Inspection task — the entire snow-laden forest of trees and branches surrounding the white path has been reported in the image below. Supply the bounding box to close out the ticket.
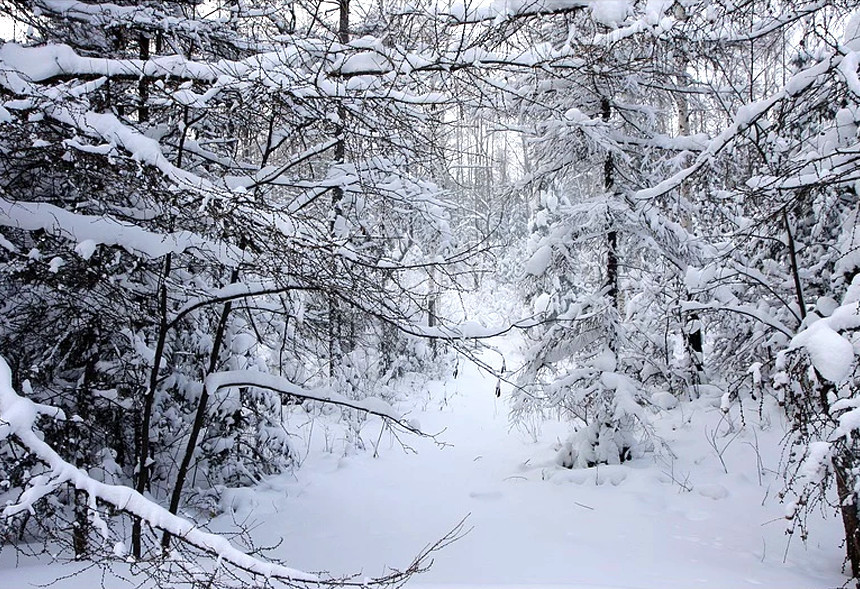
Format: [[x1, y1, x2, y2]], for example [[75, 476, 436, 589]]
[[0, 0, 860, 586]]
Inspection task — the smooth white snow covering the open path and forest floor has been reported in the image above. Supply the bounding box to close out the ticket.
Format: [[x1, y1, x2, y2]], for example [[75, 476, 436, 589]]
[[0, 338, 845, 589]]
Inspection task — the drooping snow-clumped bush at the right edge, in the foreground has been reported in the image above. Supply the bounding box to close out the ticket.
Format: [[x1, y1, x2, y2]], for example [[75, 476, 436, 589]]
[[775, 275, 860, 578]]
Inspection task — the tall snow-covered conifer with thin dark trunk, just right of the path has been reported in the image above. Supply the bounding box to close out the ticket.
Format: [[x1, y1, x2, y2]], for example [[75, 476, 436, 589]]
[[426, 2, 716, 466]]
